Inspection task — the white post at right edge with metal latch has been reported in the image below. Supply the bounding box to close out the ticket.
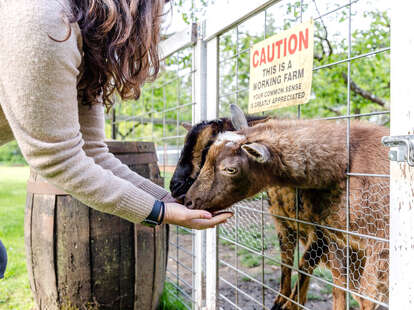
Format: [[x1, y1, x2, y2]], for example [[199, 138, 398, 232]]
[[390, 1, 414, 310]]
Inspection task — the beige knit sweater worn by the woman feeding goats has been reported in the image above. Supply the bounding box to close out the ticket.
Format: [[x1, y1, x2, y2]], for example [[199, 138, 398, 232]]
[[0, 0, 168, 223]]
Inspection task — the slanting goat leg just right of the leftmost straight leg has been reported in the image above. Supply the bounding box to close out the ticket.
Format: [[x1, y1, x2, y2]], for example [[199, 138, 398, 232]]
[[281, 228, 328, 310]]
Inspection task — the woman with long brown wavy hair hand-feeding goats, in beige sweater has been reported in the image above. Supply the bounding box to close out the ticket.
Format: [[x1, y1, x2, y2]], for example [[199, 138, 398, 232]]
[[0, 0, 233, 276]]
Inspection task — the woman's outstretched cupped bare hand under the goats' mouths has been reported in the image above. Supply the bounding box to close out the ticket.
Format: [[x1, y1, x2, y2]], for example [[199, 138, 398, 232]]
[[164, 202, 232, 229]]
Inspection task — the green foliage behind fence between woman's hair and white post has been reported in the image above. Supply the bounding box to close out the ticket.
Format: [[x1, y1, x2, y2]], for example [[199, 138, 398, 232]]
[[115, 48, 193, 146]]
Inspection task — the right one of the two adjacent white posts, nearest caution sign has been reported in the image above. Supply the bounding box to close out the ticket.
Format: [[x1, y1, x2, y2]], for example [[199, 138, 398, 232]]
[[205, 37, 219, 310]]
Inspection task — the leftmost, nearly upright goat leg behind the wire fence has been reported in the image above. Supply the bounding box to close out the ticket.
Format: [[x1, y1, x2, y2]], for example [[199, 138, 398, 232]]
[[272, 225, 297, 310]]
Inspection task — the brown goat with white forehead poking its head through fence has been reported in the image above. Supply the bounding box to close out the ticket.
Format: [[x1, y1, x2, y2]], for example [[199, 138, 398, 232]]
[[181, 105, 389, 310]]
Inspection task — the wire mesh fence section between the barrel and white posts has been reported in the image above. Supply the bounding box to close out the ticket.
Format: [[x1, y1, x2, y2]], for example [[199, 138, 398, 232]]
[[107, 46, 195, 309]]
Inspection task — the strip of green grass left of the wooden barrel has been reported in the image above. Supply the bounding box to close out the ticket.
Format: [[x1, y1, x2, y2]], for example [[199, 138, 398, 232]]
[[0, 166, 34, 310]]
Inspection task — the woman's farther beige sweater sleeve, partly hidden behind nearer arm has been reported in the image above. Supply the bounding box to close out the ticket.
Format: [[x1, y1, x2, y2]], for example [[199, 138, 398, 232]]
[[79, 104, 169, 200]]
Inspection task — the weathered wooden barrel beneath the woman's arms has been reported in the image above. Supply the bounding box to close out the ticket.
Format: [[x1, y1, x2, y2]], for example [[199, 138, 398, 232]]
[[25, 142, 168, 310]]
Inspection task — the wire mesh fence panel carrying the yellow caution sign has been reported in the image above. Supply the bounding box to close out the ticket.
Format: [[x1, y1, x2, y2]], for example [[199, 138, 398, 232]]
[[218, 0, 390, 309]]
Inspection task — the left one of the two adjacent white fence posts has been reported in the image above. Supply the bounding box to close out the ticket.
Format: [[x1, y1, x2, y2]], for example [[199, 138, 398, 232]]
[[193, 21, 207, 310]]
